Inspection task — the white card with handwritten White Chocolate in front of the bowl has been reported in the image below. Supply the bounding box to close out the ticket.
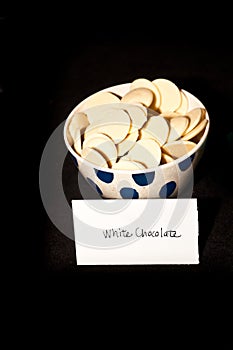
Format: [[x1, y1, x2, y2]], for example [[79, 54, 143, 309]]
[[72, 198, 199, 265]]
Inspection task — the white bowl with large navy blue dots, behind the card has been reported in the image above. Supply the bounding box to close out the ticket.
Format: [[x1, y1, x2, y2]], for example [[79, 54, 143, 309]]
[[64, 83, 209, 199]]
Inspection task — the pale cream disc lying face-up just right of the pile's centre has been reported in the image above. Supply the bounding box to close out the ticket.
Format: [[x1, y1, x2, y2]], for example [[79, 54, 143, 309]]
[[140, 116, 169, 146]]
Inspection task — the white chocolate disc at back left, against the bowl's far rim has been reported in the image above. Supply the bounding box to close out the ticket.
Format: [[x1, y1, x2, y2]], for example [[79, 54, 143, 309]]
[[78, 91, 120, 111]]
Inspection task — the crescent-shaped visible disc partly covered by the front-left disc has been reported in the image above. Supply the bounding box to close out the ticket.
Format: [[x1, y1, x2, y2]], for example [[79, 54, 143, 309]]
[[83, 134, 117, 166]]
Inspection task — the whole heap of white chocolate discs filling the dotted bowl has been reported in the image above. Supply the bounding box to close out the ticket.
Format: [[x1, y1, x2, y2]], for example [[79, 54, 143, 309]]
[[67, 78, 208, 170]]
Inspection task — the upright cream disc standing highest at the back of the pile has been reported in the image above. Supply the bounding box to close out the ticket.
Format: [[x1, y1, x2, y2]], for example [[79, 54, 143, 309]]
[[152, 79, 181, 113]]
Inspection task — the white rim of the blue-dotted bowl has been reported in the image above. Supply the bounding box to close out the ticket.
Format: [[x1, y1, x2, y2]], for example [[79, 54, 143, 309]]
[[63, 83, 210, 174]]
